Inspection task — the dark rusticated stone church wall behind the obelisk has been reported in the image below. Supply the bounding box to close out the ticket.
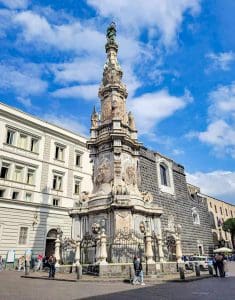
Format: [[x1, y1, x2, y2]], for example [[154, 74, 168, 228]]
[[139, 147, 213, 255]]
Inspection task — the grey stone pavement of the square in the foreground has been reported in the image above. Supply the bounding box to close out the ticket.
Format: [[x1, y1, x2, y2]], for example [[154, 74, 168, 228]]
[[0, 262, 235, 300]]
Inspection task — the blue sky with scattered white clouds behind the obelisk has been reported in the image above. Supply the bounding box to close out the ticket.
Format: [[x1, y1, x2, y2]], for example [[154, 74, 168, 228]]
[[0, 0, 235, 203]]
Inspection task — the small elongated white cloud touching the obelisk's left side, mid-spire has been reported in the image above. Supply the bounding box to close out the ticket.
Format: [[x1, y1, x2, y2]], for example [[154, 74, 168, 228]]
[[52, 84, 99, 100]]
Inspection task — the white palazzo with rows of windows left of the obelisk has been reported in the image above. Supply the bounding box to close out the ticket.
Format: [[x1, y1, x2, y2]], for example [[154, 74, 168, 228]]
[[0, 103, 92, 258]]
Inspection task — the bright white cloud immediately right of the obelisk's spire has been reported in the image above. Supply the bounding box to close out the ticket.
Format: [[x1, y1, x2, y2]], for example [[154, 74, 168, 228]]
[[129, 90, 192, 134]]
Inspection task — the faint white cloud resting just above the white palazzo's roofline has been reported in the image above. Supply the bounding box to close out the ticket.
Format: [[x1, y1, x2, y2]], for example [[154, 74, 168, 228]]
[[42, 113, 89, 136]]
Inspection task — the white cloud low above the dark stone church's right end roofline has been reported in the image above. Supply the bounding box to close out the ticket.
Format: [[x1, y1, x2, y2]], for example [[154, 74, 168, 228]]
[[186, 170, 235, 204]]
